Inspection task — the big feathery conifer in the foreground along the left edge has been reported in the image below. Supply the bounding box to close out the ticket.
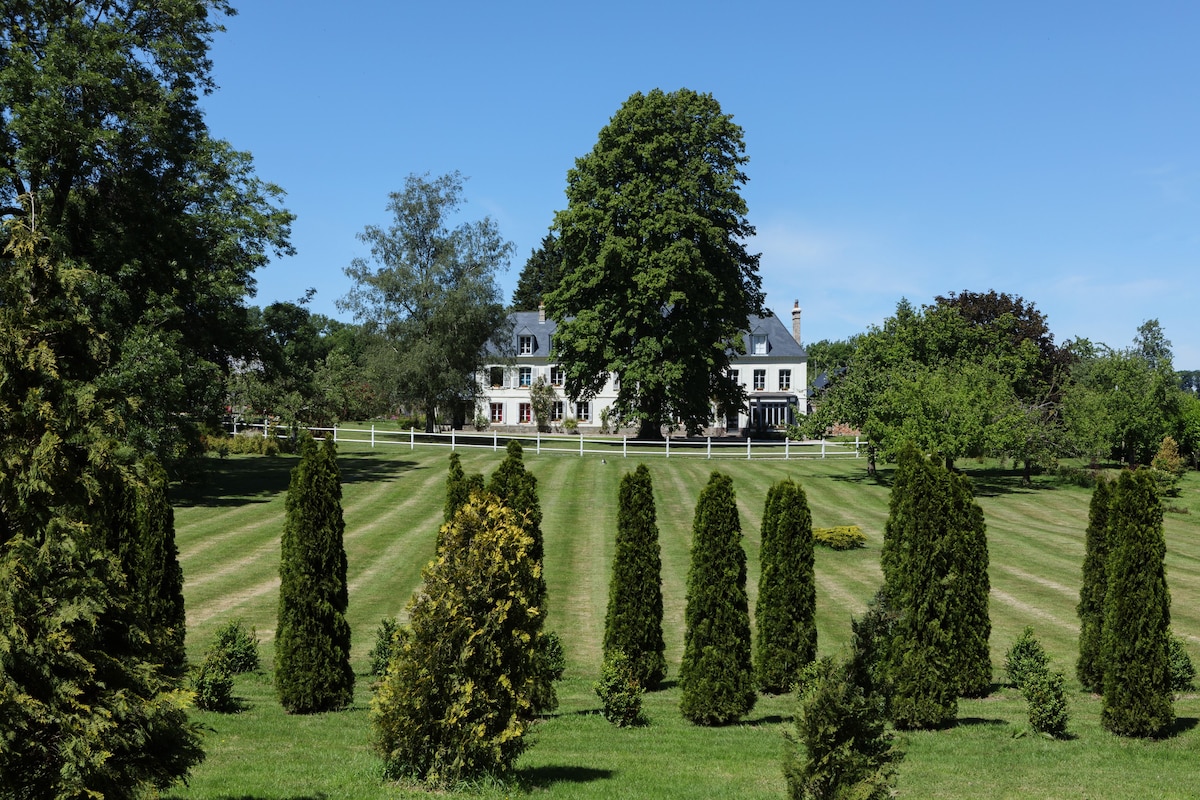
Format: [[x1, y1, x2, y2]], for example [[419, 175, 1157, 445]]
[[0, 215, 203, 798]]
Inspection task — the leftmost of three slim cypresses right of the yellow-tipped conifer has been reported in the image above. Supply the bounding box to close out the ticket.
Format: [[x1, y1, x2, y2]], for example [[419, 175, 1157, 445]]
[[604, 464, 667, 688]]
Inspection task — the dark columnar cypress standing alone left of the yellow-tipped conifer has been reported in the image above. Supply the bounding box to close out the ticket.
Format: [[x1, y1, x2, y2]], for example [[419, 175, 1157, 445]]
[[275, 433, 354, 714]]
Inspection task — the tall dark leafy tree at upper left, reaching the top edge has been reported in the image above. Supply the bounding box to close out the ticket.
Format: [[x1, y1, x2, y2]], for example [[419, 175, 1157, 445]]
[[0, 0, 292, 470]]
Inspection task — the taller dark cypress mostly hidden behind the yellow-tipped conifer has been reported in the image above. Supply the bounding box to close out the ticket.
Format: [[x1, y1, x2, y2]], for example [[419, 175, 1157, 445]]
[[487, 439, 562, 714]]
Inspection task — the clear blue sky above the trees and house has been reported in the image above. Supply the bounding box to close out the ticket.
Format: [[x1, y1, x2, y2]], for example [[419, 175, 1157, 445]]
[[204, 0, 1200, 369]]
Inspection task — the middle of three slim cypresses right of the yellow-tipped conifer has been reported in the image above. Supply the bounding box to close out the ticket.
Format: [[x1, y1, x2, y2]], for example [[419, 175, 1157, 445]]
[[679, 473, 757, 724]]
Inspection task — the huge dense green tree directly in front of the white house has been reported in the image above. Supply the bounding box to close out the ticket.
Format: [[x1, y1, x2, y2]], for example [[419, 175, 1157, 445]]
[[546, 89, 763, 438]]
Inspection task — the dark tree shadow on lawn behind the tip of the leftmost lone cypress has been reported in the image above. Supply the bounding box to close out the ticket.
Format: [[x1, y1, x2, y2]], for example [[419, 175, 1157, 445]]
[[172, 455, 415, 507]]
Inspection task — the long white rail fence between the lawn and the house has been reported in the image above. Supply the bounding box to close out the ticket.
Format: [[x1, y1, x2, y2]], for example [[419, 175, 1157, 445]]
[[229, 421, 866, 459]]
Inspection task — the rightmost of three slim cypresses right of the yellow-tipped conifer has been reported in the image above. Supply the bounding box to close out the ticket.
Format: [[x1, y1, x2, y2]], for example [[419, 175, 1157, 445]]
[[755, 480, 817, 694]]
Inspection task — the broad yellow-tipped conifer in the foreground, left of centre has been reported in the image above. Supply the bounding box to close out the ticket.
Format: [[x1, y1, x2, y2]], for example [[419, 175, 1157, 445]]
[[371, 495, 545, 786]]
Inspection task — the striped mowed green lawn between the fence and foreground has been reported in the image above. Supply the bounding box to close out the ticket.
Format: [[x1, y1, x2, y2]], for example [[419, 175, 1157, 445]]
[[168, 445, 1200, 800]]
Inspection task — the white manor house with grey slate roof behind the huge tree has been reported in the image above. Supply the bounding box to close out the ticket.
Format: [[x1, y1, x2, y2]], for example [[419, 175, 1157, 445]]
[[475, 301, 808, 435]]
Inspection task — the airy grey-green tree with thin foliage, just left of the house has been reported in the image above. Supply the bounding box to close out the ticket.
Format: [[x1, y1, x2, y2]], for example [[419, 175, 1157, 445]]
[[338, 172, 512, 432]]
